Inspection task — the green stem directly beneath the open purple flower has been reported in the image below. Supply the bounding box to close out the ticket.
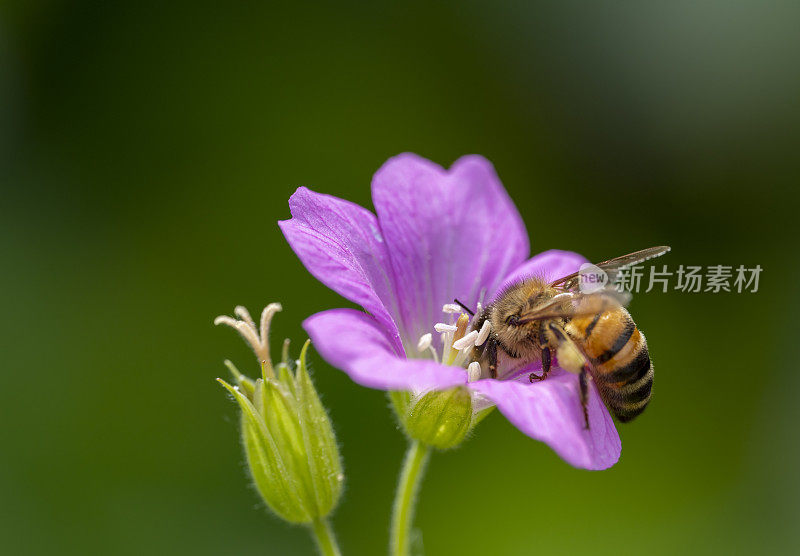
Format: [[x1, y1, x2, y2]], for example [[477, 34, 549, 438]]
[[389, 440, 431, 556]]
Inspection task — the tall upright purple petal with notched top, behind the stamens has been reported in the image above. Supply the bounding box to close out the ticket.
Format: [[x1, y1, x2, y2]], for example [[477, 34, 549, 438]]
[[372, 153, 529, 341]]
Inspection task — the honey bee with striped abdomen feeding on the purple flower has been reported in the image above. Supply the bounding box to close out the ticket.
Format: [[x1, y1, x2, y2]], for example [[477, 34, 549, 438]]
[[466, 246, 670, 428]]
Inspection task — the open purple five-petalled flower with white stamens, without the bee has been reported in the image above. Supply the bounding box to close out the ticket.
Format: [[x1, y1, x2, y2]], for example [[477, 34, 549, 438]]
[[279, 154, 621, 469]]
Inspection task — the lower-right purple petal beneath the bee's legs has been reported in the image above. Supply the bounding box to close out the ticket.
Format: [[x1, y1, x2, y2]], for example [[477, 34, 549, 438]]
[[469, 369, 622, 470]]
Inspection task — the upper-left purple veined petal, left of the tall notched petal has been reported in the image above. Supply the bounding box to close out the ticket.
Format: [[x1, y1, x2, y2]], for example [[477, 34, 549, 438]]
[[278, 187, 399, 342]]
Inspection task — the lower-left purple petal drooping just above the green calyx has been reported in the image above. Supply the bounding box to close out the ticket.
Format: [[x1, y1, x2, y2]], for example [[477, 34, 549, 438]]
[[303, 309, 467, 391]]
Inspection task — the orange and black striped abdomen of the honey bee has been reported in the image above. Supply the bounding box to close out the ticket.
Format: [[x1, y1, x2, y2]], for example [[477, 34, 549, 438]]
[[566, 307, 653, 422]]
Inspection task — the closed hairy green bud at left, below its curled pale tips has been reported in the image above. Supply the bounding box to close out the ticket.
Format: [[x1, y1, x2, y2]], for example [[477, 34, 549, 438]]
[[218, 330, 344, 523]]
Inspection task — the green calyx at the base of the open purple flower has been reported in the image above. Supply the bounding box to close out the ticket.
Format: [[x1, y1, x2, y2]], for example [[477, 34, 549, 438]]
[[390, 386, 487, 450]]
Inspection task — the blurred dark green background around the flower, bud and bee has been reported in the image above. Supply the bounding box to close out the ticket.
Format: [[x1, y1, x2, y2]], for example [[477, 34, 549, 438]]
[[0, 0, 800, 555]]
